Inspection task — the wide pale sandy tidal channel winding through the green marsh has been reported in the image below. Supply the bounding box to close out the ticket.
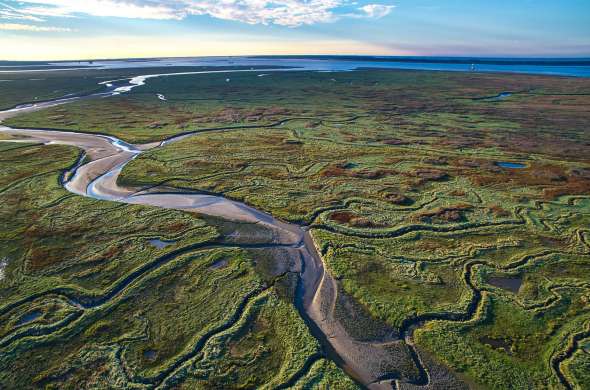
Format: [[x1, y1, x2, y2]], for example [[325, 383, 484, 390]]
[[0, 69, 415, 389]]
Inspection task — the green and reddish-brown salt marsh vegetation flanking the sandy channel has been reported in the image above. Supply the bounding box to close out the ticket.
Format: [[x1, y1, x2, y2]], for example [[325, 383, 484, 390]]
[[0, 70, 590, 388]]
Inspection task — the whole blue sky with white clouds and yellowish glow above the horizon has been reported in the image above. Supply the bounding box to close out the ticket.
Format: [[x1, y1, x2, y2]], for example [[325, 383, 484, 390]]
[[0, 0, 590, 60]]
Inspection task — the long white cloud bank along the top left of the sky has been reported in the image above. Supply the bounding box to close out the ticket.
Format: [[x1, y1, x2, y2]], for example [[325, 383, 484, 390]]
[[0, 0, 393, 27]]
